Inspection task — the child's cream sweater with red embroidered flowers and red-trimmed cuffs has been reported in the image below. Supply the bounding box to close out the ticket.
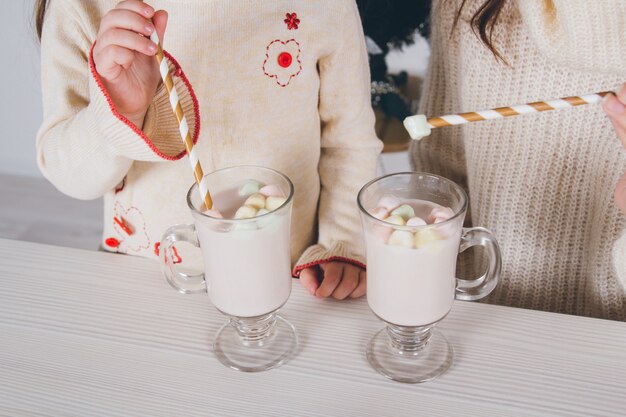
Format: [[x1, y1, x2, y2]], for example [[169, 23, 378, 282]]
[[37, 0, 381, 275]]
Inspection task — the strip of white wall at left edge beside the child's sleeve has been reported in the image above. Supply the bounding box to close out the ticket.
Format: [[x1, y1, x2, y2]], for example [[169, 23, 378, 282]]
[[0, 0, 41, 176]]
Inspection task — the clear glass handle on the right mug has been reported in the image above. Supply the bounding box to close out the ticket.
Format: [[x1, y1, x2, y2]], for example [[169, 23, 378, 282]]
[[456, 227, 502, 301]]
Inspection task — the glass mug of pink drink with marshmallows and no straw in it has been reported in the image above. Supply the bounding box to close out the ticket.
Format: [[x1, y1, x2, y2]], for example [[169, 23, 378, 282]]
[[358, 172, 502, 383]]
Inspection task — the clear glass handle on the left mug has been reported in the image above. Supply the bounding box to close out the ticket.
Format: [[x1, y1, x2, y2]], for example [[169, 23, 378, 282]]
[[159, 224, 207, 294]]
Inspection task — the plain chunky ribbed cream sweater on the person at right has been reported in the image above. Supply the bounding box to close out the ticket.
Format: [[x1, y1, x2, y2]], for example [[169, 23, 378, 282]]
[[411, 0, 626, 320]]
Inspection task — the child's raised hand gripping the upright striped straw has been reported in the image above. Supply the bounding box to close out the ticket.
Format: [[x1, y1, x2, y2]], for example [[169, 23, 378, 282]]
[[93, 0, 167, 129]]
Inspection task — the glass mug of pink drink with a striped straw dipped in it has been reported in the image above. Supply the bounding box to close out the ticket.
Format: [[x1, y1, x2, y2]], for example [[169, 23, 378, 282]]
[[160, 166, 298, 372]]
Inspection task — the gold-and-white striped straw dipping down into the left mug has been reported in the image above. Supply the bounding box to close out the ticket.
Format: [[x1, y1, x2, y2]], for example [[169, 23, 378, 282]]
[[150, 30, 213, 210]]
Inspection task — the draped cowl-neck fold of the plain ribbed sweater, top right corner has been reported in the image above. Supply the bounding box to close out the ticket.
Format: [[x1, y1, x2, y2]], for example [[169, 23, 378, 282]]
[[517, 0, 626, 76]]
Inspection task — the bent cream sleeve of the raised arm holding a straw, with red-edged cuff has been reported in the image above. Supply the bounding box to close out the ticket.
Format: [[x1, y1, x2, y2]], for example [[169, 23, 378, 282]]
[[36, 1, 200, 199]]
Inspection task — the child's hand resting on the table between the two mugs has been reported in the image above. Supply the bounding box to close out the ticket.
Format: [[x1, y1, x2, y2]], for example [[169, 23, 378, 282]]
[[300, 262, 367, 300]]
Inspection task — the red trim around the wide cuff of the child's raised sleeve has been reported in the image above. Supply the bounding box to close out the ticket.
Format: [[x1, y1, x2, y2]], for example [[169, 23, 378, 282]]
[[89, 42, 200, 161]]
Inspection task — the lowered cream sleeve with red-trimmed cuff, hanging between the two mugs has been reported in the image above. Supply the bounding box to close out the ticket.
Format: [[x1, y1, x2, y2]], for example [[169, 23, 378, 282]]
[[294, 1, 382, 276]]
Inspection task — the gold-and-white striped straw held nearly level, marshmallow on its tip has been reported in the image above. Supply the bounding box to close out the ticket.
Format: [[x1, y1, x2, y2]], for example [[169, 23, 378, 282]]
[[427, 91, 612, 129]]
